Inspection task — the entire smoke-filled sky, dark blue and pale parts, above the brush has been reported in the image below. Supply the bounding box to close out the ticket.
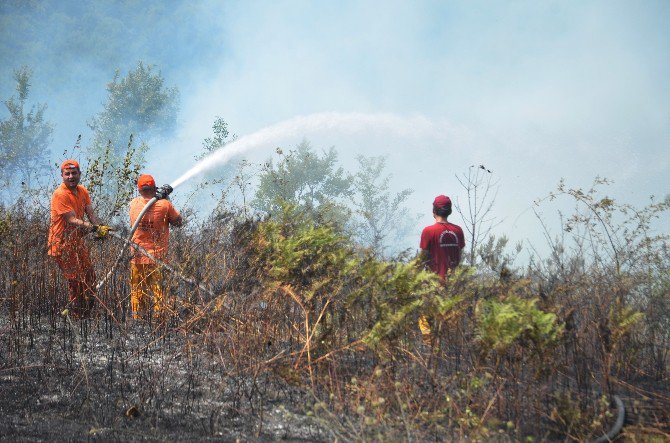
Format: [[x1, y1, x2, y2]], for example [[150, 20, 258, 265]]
[[0, 0, 670, 255]]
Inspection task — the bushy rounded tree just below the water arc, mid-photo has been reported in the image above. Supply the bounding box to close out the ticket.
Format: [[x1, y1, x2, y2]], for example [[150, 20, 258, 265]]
[[252, 141, 352, 226]]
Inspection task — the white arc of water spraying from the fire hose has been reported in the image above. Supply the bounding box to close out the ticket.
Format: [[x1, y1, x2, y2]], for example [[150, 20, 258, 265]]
[[170, 112, 437, 188]]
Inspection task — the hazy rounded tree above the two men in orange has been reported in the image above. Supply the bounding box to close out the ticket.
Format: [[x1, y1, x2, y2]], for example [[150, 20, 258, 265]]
[[89, 62, 179, 160]]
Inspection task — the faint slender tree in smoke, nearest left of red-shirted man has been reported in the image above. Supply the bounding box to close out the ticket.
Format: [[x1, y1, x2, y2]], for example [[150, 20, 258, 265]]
[[354, 155, 416, 257]]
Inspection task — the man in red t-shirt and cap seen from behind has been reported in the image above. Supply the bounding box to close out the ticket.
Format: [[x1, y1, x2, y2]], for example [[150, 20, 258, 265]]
[[419, 195, 465, 342]]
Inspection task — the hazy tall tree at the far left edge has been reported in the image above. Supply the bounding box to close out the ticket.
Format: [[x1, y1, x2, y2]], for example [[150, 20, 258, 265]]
[[0, 66, 53, 193]]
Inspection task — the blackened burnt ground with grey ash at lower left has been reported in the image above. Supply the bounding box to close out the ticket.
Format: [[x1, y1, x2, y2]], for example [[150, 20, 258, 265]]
[[0, 317, 328, 441]]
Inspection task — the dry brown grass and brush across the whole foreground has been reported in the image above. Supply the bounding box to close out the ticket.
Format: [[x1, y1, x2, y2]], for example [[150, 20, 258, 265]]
[[0, 200, 670, 441]]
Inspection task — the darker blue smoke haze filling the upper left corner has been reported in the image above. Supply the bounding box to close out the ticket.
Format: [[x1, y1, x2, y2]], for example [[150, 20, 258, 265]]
[[0, 1, 226, 158]]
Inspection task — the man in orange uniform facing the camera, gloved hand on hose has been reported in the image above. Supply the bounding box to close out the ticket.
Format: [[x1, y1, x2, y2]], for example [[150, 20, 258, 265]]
[[48, 160, 109, 318]]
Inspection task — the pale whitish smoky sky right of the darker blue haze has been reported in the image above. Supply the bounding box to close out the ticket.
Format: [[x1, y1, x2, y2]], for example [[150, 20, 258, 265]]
[[154, 1, 670, 256]]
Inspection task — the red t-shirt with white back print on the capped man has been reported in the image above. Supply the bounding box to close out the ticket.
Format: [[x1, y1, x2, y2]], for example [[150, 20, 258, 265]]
[[420, 222, 465, 279]]
